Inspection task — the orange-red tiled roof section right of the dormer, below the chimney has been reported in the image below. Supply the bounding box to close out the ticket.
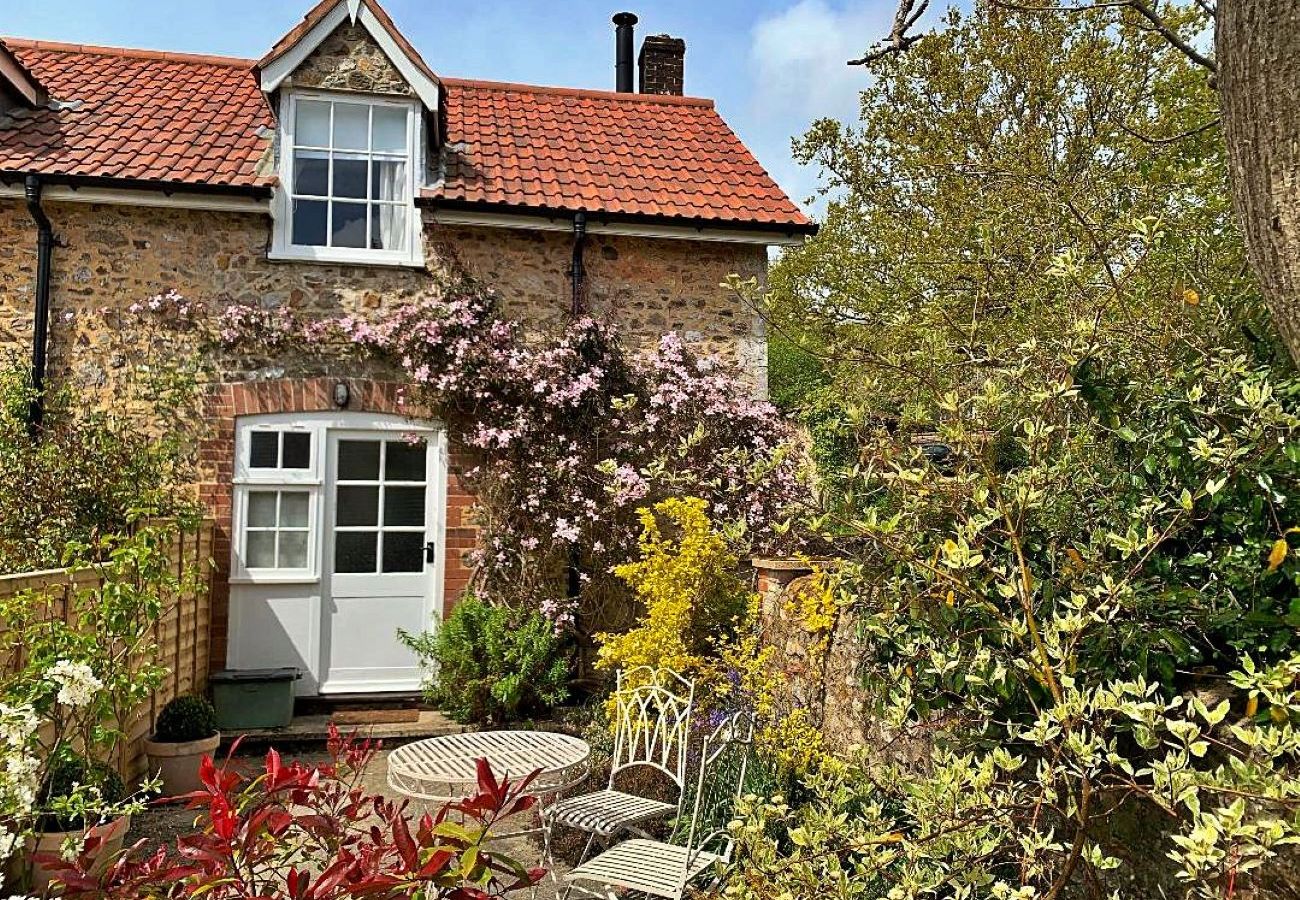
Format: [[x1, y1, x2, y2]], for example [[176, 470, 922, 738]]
[[437, 78, 809, 226]]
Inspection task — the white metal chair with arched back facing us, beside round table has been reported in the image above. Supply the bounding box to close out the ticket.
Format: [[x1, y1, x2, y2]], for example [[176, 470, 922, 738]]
[[543, 666, 696, 860]]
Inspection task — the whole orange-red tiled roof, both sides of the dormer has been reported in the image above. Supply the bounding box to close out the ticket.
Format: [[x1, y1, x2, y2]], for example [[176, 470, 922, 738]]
[[0, 38, 809, 230]]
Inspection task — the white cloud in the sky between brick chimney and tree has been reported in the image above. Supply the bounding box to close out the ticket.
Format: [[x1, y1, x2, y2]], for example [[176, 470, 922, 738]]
[[749, 0, 894, 215]]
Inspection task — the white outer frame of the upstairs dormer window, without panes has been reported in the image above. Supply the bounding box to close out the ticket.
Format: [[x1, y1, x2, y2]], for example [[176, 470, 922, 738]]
[[268, 90, 425, 267]]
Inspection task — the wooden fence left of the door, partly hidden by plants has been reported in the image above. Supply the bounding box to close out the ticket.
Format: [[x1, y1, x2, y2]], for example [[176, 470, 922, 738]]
[[0, 519, 213, 779]]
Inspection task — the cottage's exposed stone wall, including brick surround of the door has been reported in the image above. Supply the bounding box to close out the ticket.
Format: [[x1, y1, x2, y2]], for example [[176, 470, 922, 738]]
[[0, 200, 767, 663]]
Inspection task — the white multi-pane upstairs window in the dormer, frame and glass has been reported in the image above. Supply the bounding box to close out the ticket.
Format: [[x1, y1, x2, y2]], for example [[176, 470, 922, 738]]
[[272, 91, 423, 265]]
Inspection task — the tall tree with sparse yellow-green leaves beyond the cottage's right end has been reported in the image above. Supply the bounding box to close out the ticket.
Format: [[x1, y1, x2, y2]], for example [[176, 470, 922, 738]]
[[770, 4, 1271, 428]]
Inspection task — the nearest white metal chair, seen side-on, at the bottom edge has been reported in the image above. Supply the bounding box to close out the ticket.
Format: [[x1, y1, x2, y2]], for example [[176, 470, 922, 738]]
[[564, 713, 754, 900]]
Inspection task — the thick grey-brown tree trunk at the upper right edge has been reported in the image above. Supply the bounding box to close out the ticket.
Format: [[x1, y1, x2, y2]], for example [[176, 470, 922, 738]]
[[1214, 0, 1300, 362]]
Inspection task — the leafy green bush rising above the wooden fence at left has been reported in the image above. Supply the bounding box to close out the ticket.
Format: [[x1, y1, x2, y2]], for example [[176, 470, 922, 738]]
[[0, 355, 196, 572]]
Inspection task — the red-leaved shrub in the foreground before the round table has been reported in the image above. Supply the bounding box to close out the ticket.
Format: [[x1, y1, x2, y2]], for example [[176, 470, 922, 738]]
[[43, 726, 543, 900]]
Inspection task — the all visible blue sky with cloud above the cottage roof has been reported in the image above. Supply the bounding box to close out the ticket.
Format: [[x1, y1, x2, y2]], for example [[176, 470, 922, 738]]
[[0, 0, 935, 218]]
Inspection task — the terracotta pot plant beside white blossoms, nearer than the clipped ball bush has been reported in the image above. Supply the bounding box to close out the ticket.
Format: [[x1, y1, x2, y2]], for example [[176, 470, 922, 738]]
[[30, 753, 131, 895]]
